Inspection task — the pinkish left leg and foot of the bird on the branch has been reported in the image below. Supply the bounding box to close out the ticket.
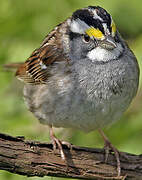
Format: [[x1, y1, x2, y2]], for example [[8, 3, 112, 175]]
[[49, 126, 72, 160]]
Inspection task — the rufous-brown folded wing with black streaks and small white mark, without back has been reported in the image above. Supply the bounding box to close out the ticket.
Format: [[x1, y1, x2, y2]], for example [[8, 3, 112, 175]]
[[16, 45, 65, 84]]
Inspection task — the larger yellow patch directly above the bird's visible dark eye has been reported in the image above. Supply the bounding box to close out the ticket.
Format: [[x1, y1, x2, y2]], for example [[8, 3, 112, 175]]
[[86, 27, 104, 39]]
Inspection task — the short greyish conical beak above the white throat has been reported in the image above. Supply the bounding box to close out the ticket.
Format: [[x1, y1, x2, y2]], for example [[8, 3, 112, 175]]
[[98, 36, 117, 50]]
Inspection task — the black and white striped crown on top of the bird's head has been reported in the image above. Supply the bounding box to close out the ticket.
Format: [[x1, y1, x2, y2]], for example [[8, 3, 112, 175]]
[[70, 6, 112, 35]]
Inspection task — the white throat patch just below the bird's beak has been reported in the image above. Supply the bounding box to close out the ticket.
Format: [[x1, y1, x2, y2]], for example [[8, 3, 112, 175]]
[[87, 43, 123, 62]]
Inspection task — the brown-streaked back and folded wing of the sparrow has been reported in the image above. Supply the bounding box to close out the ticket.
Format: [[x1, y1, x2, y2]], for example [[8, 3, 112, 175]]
[[16, 23, 67, 84]]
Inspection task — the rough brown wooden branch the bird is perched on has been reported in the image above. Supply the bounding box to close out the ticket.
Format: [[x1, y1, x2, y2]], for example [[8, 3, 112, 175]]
[[0, 134, 142, 180]]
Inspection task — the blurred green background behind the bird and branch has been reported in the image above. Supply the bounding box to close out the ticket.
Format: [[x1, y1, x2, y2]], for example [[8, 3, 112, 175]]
[[0, 0, 142, 180]]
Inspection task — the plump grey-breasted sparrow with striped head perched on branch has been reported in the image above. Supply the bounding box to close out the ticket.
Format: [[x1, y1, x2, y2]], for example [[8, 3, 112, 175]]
[[5, 6, 139, 175]]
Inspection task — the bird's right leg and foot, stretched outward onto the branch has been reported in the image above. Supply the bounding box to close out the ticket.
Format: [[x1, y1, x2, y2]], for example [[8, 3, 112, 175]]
[[98, 129, 121, 176]]
